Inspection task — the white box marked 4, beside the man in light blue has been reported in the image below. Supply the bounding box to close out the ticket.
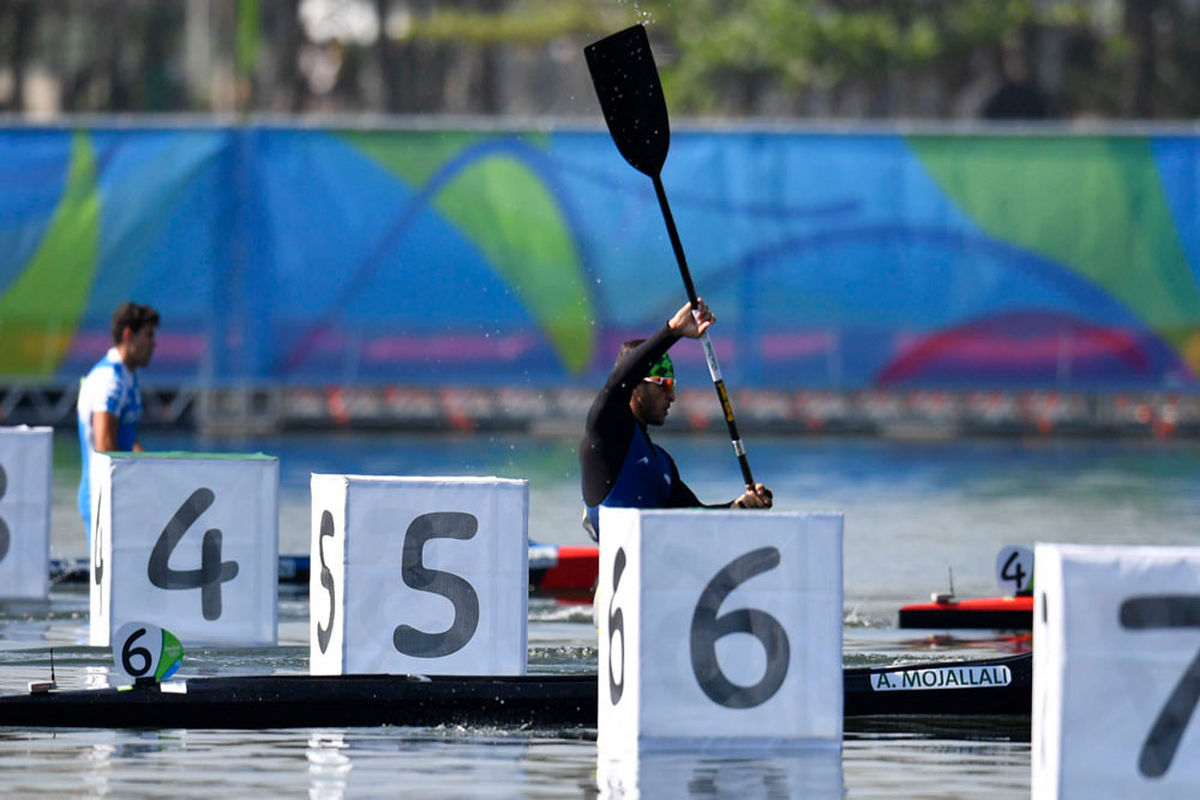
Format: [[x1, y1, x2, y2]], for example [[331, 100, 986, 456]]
[[89, 452, 280, 646]]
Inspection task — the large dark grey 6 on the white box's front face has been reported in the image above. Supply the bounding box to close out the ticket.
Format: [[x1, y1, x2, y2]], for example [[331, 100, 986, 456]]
[[691, 547, 791, 709]]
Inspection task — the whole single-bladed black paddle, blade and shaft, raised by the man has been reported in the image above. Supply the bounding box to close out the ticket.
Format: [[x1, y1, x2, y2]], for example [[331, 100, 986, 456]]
[[583, 25, 755, 496]]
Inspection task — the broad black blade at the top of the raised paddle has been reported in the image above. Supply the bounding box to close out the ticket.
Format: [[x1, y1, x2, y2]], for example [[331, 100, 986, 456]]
[[583, 25, 671, 178]]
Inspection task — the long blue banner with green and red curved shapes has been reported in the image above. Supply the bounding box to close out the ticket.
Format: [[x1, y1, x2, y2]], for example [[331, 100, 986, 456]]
[[0, 126, 1200, 391]]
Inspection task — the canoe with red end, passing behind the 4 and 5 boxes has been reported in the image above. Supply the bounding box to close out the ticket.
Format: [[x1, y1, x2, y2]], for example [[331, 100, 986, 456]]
[[50, 542, 600, 595]]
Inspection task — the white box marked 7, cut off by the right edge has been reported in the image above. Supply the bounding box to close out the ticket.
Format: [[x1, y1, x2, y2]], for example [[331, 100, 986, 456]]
[[1032, 545, 1200, 800]]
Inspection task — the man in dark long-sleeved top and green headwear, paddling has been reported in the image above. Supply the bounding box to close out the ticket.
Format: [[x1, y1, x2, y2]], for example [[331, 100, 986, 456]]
[[580, 300, 772, 541]]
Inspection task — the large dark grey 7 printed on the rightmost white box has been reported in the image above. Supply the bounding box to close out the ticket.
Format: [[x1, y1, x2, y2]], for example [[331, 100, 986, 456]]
[[1120, 595, 1200, 777]]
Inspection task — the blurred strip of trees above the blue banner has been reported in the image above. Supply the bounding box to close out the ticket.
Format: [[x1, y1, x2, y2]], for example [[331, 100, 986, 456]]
[[7, 0, 1200, 119]]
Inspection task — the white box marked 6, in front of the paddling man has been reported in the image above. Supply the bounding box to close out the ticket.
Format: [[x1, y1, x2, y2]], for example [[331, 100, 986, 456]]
[[595, 509, 842, 752]]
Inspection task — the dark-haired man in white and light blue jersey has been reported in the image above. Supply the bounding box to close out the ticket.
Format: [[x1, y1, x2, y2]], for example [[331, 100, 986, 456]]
[[76, 302, 158, 549]]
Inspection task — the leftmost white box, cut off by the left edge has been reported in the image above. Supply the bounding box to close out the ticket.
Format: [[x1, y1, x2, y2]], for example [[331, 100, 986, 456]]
[[0, 426, 53, 600]]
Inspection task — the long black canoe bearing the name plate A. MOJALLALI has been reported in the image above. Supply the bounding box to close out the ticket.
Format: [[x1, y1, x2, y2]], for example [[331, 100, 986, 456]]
[[0, 654, 1033, 730]]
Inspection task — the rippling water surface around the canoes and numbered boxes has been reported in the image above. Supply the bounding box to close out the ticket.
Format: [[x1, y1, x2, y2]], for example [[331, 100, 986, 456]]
[[9, 433, 1200, 800]]
